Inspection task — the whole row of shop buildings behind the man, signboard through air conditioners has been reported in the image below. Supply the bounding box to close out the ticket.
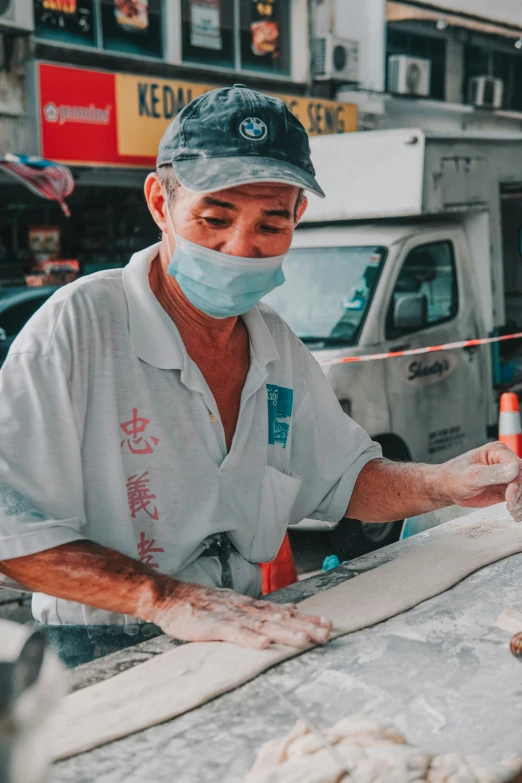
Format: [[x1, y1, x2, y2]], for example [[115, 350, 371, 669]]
[[0, 0, 522, 285]]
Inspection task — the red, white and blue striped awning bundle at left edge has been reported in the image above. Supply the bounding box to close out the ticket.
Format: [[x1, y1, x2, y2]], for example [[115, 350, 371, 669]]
[[0, 155, 74, 217]]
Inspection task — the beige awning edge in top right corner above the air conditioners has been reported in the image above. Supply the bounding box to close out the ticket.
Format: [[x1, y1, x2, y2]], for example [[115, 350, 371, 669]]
[[386, 0, 522, 40]]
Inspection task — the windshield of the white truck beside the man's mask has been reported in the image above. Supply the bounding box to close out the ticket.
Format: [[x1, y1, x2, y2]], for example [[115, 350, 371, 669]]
[[264, 247, 387, 348]]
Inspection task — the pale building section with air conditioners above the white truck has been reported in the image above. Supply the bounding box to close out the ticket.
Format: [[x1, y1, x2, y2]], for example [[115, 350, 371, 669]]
[[328, 0, 522, 133]]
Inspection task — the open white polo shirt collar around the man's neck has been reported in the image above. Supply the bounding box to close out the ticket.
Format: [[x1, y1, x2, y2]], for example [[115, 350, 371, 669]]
[[123, 242, 279, 370]]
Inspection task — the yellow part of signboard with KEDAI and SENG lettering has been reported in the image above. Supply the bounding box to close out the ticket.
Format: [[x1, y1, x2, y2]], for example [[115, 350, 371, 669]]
[[115, 73, 357, 158]]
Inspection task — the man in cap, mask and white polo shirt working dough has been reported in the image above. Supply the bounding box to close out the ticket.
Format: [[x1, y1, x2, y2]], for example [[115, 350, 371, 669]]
[[0, 85, 522, 660]]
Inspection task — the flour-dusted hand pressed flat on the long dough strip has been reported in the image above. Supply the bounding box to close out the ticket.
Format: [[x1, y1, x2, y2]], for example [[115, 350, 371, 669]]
[[144, 580, 332, 650]]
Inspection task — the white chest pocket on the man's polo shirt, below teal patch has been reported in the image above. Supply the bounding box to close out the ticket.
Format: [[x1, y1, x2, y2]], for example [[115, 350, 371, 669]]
[[248, 465, 303, 563]]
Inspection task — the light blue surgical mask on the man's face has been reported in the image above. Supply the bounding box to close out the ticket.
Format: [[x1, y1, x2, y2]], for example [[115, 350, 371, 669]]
[[167, 210, 285, 318]]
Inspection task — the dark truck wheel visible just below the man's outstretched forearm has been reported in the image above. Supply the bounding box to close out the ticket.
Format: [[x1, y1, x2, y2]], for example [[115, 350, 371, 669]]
[[328, 519, 402, 561]]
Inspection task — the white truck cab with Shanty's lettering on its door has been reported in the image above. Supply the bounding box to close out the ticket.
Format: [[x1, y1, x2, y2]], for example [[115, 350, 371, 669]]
[[266, 222, 491, 462]]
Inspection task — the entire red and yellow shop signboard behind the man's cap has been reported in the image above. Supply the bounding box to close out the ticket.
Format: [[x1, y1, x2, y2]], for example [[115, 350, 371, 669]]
[[38, 63, 357, 168]]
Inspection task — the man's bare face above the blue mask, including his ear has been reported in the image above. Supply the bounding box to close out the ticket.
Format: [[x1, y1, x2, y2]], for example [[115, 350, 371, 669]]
[[145, 174, 306, 258]]
